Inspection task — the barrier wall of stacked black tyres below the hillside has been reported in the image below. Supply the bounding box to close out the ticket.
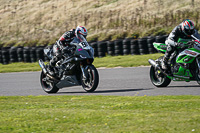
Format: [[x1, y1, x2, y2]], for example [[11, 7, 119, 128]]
[[0, 35, 168, 64]]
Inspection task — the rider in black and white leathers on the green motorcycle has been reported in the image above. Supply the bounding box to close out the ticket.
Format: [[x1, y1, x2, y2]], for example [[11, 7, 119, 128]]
[[161, 19, 195, 70]]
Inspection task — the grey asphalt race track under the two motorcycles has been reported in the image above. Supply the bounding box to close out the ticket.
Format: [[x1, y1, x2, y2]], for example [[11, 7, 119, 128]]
[[0, 67, 200, 96]]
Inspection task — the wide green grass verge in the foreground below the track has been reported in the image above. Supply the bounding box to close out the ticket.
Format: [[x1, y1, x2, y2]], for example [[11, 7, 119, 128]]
[[0, 96, 200, 133]]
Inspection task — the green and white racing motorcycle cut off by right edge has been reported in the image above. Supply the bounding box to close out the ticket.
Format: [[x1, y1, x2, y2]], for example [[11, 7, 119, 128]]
[[149, 36, 200, 87]]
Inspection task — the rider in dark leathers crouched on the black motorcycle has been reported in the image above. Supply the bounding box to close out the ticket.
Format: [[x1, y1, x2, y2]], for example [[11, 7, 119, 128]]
[[48, 26, 87, 76]]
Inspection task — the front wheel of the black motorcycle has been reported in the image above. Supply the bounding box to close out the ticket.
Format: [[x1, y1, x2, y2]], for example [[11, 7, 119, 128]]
[[81, 65, 99, 92]]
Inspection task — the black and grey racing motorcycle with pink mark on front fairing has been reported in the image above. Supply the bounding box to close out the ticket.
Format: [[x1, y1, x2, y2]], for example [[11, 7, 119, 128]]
[[39, 35, 99, 93]]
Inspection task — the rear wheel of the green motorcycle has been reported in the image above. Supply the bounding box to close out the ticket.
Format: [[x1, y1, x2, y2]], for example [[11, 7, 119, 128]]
[[150, 66, 171, 87]]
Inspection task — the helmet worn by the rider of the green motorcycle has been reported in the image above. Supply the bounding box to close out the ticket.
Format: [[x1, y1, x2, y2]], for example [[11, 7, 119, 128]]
[[181, 19, 194, 36]]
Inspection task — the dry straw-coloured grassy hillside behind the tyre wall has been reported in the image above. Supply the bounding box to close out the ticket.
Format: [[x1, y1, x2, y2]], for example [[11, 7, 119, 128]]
[[0, 0, 200, 46]]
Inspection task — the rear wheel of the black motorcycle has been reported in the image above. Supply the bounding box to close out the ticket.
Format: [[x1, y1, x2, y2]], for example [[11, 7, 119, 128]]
[[40, 71, 59, 93]]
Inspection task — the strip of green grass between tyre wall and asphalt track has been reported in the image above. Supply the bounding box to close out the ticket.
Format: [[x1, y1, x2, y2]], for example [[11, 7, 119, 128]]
[[0, 54, 162, 73]]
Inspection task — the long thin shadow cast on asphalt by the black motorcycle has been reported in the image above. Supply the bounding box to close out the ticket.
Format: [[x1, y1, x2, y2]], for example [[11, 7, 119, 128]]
[[57, 88, 154, 94]]
